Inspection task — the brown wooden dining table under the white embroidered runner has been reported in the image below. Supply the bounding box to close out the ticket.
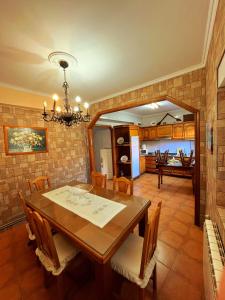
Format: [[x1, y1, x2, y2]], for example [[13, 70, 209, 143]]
[[26, 181, 151, 300]]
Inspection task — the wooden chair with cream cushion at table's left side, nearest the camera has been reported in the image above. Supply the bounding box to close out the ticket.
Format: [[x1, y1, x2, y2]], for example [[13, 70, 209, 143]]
[[28, 208, 79, 299]]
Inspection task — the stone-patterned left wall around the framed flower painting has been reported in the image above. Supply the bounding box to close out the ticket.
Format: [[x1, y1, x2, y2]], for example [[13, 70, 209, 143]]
[[0, 104, 88, 226]]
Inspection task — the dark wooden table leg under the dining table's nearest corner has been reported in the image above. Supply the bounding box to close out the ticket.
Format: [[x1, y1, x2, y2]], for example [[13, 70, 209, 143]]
[[95, 261, 112, 300]]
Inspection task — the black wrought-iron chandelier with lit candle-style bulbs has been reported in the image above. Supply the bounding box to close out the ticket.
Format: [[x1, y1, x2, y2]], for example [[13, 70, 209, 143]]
[[42, 56, 91, 127]]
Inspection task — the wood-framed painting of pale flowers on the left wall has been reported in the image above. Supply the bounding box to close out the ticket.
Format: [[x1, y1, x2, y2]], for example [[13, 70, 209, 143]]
[[3, 126, 48, 155]]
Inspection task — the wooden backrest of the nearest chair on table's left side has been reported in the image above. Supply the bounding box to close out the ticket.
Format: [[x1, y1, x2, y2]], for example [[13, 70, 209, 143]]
[[28, 208, 60, 268]]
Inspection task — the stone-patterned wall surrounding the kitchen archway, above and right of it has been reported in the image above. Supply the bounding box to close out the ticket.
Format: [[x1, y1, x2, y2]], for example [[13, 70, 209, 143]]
[[91, 69, 206, 223]]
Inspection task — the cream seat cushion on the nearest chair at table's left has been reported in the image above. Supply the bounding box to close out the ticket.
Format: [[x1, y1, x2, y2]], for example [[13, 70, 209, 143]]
[[35, 233, 79, 276]]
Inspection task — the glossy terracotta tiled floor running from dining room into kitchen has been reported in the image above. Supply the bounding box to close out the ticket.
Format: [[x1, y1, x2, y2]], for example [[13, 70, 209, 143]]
[[0, 174, 203, 300]]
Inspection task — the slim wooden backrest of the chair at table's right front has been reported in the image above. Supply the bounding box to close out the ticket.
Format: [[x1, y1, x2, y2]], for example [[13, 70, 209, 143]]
[[139, 201, 162, 279]]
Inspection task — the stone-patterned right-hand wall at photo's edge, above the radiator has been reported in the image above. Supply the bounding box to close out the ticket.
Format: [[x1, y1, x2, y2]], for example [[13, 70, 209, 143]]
[[206, 0, 225, 243]]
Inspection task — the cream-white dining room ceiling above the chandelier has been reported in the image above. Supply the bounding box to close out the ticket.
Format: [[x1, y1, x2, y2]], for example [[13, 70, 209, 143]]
[[0, 0, 210, 101]]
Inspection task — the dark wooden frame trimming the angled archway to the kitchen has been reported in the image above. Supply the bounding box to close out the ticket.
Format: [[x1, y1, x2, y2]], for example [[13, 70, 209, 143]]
[[87, 95, 200, 226]]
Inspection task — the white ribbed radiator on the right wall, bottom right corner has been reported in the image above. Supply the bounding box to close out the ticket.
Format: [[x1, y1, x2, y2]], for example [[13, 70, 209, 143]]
[[203, 220, 225, 300]]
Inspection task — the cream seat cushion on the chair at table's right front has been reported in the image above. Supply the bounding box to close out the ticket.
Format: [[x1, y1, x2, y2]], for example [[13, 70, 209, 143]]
[[111, 234, 156, 288]]
